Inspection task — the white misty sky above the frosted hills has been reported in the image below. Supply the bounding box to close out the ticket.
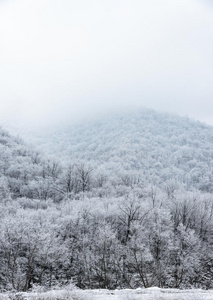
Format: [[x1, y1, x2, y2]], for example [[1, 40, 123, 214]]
[[0, 0, 213, 125]]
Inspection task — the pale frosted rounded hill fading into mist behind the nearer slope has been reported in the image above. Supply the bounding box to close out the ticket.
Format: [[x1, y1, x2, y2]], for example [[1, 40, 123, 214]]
[[27, 110, 213, 191]]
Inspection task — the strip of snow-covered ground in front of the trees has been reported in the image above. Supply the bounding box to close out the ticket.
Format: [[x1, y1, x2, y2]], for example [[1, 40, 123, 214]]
[[0, 288, 213, 300]]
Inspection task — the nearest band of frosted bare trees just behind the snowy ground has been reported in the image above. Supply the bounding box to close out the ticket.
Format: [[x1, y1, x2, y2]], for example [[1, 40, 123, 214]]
[[0, 188, 213, 290]]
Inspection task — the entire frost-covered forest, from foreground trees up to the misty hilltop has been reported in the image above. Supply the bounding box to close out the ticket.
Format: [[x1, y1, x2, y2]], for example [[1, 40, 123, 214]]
[[0, 111, 213, 290]]
